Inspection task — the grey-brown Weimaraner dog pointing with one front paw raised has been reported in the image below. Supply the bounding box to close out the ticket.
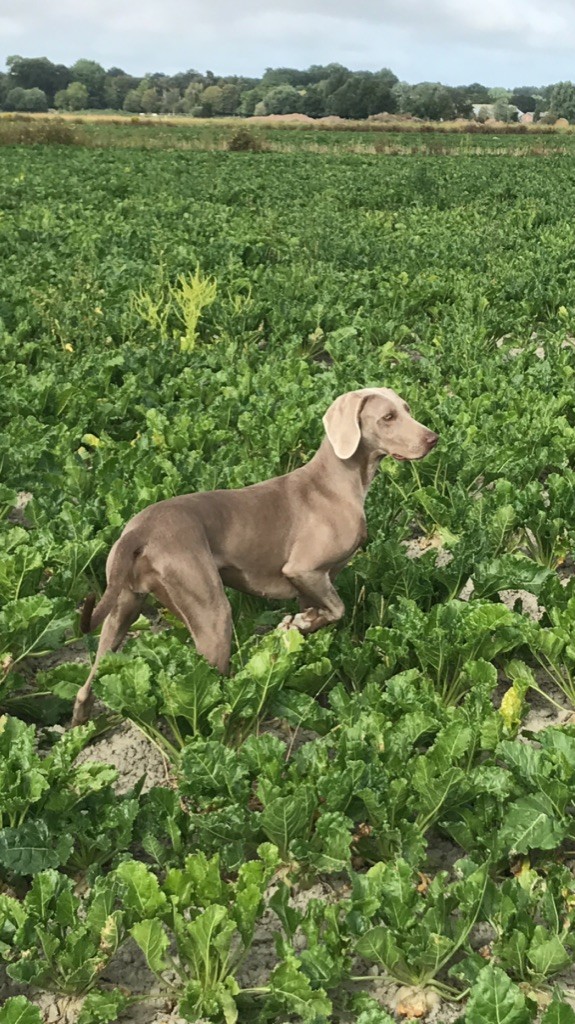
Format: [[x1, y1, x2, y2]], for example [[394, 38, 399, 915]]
[[73, 388, 439, 725]]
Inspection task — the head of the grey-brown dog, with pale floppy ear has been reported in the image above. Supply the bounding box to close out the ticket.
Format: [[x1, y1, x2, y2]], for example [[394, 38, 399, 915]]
[[323, 387, 439, 462]]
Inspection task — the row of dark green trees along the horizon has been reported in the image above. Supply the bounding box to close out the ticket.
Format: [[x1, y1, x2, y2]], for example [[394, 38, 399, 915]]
[[0, 55, 575, 121]]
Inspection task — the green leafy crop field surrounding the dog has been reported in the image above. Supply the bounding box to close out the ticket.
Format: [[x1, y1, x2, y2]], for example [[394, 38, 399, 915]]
[[0, 133, 575, 1024]]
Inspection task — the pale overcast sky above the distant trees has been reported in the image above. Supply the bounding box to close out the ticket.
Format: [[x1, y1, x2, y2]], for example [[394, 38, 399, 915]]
[[0, 0, 575, 86]]
